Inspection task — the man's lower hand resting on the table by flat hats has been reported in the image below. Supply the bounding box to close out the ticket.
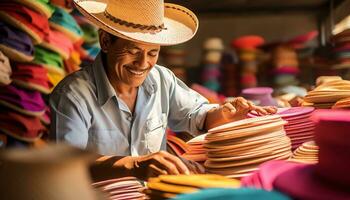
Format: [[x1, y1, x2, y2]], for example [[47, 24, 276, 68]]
[[114, 151, 190, 179]]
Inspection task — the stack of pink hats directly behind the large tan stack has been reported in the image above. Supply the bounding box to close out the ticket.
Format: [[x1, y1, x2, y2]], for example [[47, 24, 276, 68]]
[[277, 107, 315, 150]]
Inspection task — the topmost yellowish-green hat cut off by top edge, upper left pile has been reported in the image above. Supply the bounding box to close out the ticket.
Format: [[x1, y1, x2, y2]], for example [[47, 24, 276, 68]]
[[13, 0, 55, 18]]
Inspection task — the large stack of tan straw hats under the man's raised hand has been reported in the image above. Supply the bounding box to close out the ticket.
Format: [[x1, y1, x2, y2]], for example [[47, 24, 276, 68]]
[[204, 115, 291, 178]]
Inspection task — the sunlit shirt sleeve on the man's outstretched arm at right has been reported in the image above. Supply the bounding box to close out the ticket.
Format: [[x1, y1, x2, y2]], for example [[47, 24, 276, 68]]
[[164, 68, 218, 136]]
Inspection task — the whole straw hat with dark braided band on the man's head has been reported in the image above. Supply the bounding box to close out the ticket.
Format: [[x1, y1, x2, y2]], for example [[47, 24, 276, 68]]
[[74, 0, 198, 46]]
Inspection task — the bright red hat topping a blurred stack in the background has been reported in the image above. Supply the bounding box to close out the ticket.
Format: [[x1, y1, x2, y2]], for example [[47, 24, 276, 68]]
[[231, 35, 265, 49]]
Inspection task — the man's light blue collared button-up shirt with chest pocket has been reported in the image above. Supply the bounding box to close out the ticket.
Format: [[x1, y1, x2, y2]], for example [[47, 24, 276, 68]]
[[50, 55, 216, 156]]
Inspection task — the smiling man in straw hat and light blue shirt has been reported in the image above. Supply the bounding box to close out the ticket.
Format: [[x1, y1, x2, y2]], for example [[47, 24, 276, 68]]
[[50, 0, 275, 178]]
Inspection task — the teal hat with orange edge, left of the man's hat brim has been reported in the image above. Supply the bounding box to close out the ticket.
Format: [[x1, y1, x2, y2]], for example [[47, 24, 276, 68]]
[[50, 8, 83, 42]]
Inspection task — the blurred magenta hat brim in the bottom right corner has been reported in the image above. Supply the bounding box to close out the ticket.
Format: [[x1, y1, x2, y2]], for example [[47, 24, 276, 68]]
[[274, 165, 350, 200]]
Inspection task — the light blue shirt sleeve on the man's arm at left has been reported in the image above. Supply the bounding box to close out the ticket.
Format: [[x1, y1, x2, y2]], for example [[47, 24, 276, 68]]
[[49, 91, 88, 149]]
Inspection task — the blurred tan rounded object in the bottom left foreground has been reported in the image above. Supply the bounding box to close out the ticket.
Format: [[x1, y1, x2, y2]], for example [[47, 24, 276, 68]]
[[0, 145, 102, 200]]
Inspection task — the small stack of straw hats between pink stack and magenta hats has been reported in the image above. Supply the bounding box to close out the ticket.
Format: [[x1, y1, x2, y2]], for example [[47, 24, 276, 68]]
[[290, 141, 318, 163]]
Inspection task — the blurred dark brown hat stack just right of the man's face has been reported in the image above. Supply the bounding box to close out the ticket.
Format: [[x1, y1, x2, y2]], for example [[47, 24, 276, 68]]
[[161, 44, 187, 83]]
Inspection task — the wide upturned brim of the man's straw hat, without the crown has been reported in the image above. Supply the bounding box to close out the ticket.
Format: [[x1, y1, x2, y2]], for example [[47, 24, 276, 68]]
[[74, 0, 198, 46]]
